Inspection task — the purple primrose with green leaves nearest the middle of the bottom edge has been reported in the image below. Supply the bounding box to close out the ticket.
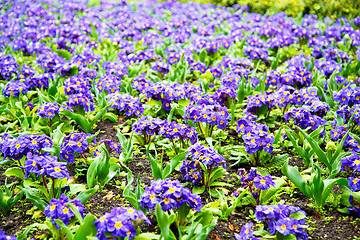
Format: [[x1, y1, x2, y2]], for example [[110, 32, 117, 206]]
[[138, 178, 216, 240]]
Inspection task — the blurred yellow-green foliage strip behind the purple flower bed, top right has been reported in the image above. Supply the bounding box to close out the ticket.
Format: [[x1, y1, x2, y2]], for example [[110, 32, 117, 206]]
[[186, 0, 360, 20]]
